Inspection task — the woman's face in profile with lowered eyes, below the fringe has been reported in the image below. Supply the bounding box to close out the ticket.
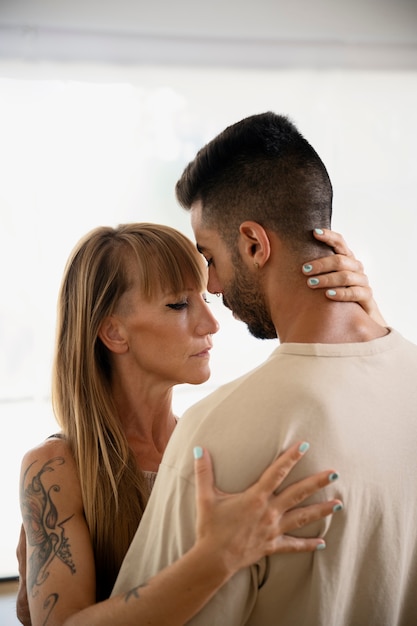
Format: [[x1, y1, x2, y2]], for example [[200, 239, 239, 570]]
[[114, 278, 219, 385]]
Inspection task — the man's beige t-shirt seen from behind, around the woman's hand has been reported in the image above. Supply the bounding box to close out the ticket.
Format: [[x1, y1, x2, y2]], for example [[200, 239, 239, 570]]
[[112, 332, 417, 626]]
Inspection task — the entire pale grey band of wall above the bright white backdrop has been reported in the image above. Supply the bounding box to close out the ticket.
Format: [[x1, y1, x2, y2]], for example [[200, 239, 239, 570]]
[[0, 0, 417, 70]]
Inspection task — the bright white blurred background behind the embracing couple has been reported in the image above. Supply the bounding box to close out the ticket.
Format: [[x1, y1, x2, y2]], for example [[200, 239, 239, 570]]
[[0, 0, 417, 578]]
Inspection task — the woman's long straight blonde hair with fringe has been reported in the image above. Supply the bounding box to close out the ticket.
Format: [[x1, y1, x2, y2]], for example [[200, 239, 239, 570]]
[[52, 223, 207, 600]]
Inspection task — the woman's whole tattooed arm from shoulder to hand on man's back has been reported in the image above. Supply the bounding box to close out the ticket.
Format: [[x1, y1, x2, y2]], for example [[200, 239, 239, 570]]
[[17, 440, 341, 626]]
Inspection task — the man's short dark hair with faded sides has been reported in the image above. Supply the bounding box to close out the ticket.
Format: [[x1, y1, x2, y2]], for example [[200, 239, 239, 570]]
[[176, 112, 333, 253]]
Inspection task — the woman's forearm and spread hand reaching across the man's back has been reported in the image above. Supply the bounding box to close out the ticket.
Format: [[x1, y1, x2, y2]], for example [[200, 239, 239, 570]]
[[65, 443, 342, 626]]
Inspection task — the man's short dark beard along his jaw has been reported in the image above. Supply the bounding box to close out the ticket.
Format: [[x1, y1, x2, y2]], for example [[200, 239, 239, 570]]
[[223, 261, 277, 339]]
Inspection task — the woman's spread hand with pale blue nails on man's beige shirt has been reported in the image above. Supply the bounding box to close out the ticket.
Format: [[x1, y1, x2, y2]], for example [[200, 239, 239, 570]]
[[195, 442, 343, 573]]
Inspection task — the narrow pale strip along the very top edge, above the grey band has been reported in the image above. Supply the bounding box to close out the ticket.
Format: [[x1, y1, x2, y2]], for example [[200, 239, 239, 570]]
[[0, 0, 417, 44]]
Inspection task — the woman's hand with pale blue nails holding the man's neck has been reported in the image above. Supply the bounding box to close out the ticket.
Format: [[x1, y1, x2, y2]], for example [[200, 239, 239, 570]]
[[303, 228, 386, 326]]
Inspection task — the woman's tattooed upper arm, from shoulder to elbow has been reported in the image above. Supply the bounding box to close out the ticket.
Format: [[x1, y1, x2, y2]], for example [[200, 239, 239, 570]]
[[19, 439, 95, 626]]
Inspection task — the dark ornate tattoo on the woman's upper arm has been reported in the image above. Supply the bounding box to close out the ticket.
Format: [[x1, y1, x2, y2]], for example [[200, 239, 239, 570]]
[[21, 457, 76, 604]]
